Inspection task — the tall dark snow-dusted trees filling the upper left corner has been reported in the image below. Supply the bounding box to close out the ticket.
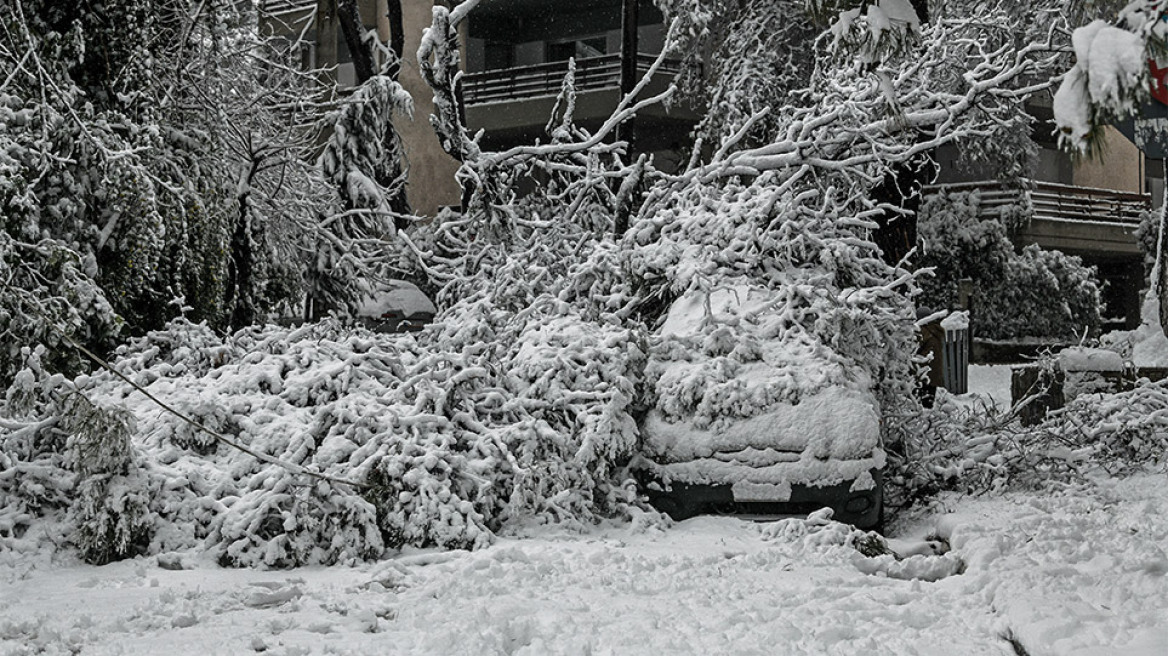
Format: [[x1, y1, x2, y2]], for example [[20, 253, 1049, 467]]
[[0, 0, 399, 379]]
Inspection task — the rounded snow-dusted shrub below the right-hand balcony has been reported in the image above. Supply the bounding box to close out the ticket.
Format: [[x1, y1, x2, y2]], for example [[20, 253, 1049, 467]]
[[919, 191, 1103, 340]]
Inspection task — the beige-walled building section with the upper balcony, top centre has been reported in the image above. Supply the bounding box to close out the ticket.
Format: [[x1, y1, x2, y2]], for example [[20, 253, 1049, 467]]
[[262, 0, 698, 215]]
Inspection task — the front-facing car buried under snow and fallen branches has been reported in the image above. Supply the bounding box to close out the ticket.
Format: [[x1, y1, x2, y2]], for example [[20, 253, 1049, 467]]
[[634, 285, 885, 528]]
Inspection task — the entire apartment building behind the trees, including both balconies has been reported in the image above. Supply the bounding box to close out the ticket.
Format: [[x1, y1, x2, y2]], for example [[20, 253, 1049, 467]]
[[265, 0, 1149, 328]]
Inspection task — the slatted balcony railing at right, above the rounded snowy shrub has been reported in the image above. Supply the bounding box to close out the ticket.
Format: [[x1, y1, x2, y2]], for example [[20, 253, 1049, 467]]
[[925, 181, 1152, 225]]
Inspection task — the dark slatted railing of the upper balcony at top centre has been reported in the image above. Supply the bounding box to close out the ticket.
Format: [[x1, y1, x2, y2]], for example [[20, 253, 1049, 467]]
[[463, 53, 677, 105]]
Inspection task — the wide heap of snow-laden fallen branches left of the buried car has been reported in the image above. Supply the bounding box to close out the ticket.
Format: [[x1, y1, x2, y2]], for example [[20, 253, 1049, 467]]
[[0, 303, 644, 560]]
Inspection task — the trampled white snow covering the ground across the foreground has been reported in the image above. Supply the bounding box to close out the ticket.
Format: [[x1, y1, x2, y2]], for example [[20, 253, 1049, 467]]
[[0, 368, 1168, 656]]
